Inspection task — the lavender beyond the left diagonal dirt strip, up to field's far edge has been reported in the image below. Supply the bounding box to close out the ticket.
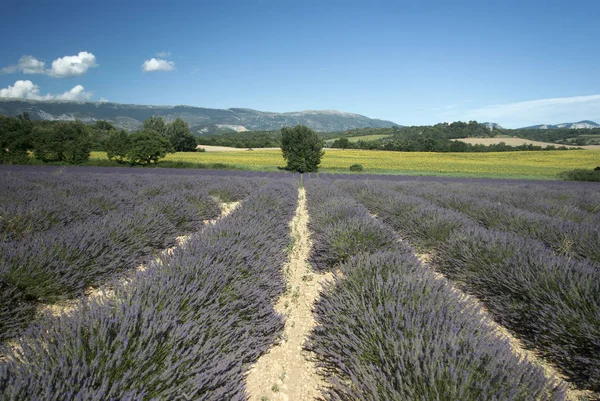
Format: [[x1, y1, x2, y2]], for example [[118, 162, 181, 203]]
[[0, 171, 263, 341]]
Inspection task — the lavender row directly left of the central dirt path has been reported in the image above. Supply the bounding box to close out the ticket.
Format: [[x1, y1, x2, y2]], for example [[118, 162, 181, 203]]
[[0, 181, 298, 400]]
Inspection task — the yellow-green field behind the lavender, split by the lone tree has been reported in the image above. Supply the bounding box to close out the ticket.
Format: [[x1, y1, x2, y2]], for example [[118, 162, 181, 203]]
[[92, 149, 600, 179]]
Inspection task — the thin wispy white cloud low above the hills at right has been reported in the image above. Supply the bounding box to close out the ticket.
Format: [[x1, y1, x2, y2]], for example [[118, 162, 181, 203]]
[[464, 95, 600, 128]]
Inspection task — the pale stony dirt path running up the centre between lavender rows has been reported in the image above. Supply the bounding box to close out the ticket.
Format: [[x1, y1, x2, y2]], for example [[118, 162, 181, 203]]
[[246, 188, 333, 401]]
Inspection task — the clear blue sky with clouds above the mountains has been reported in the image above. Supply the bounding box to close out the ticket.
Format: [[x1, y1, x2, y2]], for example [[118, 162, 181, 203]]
[[0, 0, 600, 128]]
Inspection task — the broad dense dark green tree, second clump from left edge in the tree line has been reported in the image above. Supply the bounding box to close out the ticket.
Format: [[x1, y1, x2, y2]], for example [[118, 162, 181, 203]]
[[33, 121, 92, 164]]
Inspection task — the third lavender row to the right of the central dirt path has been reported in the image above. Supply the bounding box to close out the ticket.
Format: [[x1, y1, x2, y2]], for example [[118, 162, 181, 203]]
[[384, 179, 600, 262]]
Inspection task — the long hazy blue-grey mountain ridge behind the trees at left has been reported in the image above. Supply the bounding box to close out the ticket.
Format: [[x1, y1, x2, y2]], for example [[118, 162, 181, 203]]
[[0, 99, 397, 134]]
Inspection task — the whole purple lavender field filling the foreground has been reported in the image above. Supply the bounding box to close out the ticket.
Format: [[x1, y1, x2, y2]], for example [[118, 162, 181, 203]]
[[0, 166, 600, 401]]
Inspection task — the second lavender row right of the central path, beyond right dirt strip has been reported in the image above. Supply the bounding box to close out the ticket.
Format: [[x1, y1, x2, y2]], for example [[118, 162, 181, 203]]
[[338, 181, 600, 391]]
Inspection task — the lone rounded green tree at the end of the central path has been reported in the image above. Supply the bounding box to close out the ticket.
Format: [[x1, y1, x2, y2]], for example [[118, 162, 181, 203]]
[[281, 125, 325, 173]]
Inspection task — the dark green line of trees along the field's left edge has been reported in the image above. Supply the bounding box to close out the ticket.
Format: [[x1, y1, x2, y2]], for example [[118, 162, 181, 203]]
[[0, 113, 196, 164]]
